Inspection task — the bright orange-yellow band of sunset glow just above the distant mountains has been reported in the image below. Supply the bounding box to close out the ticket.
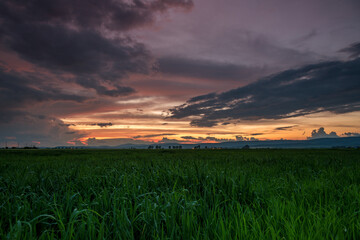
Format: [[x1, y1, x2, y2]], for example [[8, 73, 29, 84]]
[[62, 110, 360, 144]]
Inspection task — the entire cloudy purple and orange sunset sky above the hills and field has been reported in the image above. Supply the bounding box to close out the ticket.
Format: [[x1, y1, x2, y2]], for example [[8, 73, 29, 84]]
[[0, 0, 360, 147]]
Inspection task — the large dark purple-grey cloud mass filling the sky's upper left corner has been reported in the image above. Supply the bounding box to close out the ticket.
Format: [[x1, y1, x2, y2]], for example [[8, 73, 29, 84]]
[[0, 0, 193, 97]]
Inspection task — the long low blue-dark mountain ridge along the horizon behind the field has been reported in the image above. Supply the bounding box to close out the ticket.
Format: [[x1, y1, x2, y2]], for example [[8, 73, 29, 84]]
[[53, 137, 360, 149]]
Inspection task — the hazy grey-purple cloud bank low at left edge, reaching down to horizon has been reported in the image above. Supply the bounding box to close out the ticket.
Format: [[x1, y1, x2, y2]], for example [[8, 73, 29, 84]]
[[0, 69, 87, 146]]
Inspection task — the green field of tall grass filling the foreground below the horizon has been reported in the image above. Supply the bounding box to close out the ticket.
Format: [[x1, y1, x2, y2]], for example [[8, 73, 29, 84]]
[[0, 149, 360, 240]]
